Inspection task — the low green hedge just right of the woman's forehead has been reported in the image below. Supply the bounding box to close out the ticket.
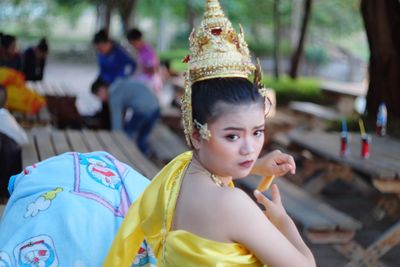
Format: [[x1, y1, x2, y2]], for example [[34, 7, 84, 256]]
[[263, 76, 322, 105]]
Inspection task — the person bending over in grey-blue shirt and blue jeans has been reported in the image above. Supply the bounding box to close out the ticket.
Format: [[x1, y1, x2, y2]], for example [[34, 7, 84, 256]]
[[91, 78, 160, 156]]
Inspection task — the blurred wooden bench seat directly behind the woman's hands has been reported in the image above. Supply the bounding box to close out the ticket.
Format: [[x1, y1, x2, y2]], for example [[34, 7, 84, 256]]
[[239, 176, 361, 244]]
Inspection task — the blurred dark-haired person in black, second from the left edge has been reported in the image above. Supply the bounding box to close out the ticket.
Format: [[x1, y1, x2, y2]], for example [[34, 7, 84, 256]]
[[23, 38, 49, 81]]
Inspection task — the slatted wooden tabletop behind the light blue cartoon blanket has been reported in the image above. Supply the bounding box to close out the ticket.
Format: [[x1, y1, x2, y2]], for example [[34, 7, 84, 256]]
[[22, 128, 158, 179]]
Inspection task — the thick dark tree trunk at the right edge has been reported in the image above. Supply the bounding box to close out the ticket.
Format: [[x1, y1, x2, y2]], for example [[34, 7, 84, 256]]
[[361, 0, 400, 119]]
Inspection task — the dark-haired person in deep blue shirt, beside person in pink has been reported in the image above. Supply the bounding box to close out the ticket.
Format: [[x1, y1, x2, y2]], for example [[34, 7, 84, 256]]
[[93, 29, 137, 84]]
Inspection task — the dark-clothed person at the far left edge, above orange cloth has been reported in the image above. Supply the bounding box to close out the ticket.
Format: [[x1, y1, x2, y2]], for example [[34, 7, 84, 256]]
[[0, 34, 22, 71]]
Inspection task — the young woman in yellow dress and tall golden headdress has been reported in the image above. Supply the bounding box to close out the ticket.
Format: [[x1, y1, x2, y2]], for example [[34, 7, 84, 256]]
[[105, 0, 315, 267]]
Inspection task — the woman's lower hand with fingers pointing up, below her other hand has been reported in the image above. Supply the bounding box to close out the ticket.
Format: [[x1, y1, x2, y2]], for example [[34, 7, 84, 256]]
[[254, 184, 290, 229]]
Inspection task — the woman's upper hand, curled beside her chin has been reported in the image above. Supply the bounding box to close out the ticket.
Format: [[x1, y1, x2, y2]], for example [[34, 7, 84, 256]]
[[251, 150, 296, 177]]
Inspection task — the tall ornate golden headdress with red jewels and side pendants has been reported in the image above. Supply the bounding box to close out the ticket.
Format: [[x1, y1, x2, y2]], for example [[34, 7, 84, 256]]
[[182, 0, 268, 146]]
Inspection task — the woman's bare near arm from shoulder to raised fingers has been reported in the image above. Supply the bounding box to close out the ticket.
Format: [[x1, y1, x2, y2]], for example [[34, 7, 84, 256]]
[[224, 185, 316, 267]]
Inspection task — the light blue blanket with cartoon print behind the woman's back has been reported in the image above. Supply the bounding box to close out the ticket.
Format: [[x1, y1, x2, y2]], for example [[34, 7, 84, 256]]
[[0, 152, 155, 267]]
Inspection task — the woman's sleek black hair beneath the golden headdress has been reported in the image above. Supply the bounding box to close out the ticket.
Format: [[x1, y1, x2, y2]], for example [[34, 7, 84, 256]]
[[192, 78, 264, 124]]
